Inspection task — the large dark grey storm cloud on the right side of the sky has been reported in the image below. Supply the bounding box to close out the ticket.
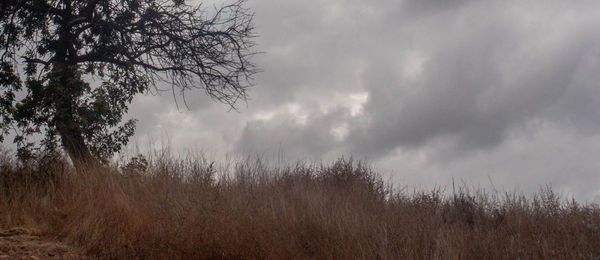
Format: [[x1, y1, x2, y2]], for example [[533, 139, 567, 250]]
[[350, 8, 600, 159]]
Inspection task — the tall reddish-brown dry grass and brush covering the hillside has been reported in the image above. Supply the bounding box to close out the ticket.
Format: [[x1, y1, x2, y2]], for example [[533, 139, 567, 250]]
[[0, 151, 600, 259]]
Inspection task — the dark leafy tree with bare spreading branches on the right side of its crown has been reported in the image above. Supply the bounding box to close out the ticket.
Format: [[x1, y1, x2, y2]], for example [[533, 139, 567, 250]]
[[0, 0, 255, 161]]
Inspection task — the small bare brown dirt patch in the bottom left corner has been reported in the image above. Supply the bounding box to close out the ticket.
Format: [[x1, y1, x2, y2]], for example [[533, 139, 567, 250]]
[[0, 228, 88, 260]]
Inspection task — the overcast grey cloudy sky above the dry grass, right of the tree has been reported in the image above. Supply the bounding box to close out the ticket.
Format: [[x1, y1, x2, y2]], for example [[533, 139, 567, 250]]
[[129, 0, 600, 203]]
